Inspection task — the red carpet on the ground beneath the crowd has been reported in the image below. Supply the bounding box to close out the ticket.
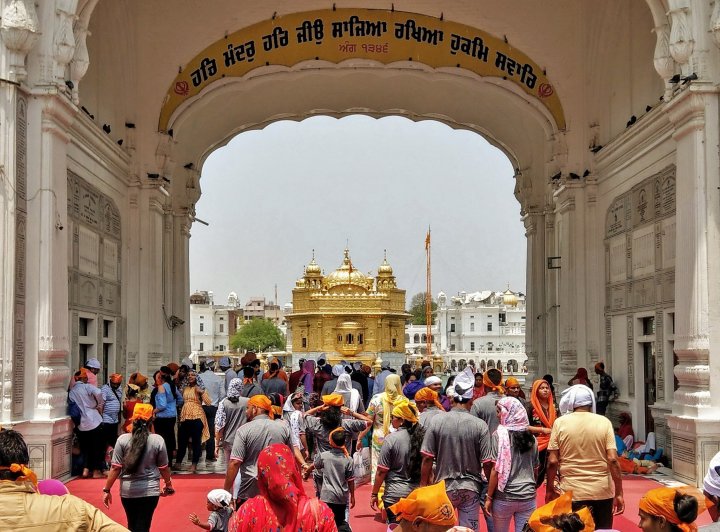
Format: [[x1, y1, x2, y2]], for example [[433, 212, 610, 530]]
[[67, 474, 710, 532]]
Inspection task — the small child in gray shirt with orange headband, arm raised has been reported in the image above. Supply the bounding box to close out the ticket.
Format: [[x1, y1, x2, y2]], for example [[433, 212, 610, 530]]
[[310, 427, 355, 530]]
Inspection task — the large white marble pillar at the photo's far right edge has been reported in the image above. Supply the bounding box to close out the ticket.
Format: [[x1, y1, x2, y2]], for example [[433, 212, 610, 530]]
[[666, 83, 720, 484]]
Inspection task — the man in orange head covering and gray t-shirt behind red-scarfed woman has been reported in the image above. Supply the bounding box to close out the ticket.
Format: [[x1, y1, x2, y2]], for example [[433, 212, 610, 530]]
[[224, 394, 292, 504]]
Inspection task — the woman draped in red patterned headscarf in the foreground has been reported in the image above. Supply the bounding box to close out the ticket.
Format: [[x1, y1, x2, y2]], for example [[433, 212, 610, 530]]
[[229, 443, 337, 532]]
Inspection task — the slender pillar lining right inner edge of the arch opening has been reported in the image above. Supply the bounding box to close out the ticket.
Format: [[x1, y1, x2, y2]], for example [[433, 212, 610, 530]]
[[523, 212, 548, 387]]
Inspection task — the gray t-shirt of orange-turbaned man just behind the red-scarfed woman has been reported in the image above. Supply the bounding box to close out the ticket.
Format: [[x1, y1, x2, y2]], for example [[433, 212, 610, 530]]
[[230, 414, 292, 499]]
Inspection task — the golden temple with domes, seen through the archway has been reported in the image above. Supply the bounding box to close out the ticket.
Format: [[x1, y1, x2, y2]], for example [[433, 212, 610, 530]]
[[287, 248, 409, 365]]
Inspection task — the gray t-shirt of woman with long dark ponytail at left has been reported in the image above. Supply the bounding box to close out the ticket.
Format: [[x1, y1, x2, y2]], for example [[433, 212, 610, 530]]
[[112, 434, 168, 498]]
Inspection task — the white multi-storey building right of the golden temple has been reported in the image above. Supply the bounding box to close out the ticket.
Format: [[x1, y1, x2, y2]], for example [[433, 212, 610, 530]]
[[434, 289, 527, 373]]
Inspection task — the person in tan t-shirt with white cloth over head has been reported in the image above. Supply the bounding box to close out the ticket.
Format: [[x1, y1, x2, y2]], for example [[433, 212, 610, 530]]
[[545, 384, 625, 528]]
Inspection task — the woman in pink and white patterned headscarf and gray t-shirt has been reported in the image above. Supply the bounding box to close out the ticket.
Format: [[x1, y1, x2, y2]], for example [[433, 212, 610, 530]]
[[485, 397, 539, 532]]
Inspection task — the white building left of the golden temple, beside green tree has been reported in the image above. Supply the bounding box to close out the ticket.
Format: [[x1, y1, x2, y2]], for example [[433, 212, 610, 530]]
[[190, 291, 242, 360]]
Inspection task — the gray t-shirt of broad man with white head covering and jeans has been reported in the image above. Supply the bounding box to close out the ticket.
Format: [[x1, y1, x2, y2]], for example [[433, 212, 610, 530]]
[[422, 407, 491, 492]]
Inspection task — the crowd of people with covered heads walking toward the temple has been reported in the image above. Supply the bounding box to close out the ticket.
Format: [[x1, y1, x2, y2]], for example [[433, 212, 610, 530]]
[[0, 353, 720, 532]]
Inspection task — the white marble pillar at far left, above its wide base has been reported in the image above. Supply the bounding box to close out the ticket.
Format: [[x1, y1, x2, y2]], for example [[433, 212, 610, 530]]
[[23, 96, 75, 420]]
